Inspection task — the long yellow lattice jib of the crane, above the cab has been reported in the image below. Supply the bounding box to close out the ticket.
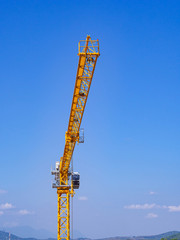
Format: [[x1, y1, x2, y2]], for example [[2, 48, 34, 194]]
[[60, 36, 100, 179]]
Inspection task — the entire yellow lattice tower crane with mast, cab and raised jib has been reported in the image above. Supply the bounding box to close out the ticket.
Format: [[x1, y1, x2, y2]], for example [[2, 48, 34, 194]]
[[52, 36, 100, 240]]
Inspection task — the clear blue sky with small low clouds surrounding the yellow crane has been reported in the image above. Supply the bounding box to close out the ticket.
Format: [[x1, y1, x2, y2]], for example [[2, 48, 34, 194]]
[[0, 0, 180, 238]]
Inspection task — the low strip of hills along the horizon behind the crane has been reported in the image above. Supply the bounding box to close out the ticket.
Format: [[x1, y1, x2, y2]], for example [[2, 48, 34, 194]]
[[0, 231, 180, 240]]
